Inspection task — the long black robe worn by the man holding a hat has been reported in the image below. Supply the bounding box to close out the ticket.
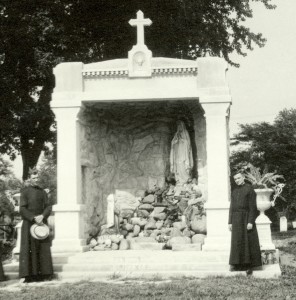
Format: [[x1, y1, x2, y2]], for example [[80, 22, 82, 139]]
[[19, 186, 53, 277]]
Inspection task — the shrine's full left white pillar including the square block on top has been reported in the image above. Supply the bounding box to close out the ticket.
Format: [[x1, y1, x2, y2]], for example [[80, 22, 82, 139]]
[[51, 63, 88, 253]]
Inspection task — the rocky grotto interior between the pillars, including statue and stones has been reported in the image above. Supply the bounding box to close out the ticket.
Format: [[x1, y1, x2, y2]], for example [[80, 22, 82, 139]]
[[79, 100, 207, 250]]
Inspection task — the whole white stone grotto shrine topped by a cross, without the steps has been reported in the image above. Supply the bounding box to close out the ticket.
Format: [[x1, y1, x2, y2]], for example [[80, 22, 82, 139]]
[[51, 11, 231, 253]]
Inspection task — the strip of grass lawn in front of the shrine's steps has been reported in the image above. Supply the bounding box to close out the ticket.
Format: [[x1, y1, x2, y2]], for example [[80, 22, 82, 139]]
[[0, 267, 296, 300]]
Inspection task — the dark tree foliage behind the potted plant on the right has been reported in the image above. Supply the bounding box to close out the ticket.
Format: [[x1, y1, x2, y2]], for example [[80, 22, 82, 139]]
[[231, 109, 296, 218]]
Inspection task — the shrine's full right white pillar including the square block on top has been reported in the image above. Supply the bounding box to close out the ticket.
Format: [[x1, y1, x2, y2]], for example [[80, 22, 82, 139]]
[[197, 57, 231, 251]]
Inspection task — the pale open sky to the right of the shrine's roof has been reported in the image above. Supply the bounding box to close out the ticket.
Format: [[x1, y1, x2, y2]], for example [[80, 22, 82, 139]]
[[227, 0, 296, 134]]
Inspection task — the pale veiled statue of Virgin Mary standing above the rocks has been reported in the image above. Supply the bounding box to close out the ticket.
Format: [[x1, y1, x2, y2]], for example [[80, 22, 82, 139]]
[[170, 121, 193, 185]]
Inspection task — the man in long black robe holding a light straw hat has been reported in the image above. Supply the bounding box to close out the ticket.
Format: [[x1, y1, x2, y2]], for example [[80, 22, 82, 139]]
[[19, 170, 53, 282]]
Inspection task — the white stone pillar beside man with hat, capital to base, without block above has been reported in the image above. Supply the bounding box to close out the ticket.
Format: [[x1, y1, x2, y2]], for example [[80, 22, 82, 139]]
[[52, 107, 87, 252]]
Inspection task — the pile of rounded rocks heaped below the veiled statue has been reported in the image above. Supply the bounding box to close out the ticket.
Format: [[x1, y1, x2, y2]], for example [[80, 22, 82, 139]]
[[90, 180, 206, 250]]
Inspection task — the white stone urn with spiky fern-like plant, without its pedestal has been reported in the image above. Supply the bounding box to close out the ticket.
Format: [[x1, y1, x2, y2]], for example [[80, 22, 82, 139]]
[[243, 163, 285, 219]]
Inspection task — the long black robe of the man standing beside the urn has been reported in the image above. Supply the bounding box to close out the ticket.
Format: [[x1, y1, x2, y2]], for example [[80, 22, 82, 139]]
[[228, 184, 262, 267]]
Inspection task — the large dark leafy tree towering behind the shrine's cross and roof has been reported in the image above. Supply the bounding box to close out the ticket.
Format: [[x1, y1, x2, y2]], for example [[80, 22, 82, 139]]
[[0, 0, 274, 179]]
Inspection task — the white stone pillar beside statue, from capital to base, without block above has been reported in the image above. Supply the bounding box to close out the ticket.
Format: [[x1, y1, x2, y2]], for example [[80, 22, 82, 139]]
[[202, 103, 230, 250]]
